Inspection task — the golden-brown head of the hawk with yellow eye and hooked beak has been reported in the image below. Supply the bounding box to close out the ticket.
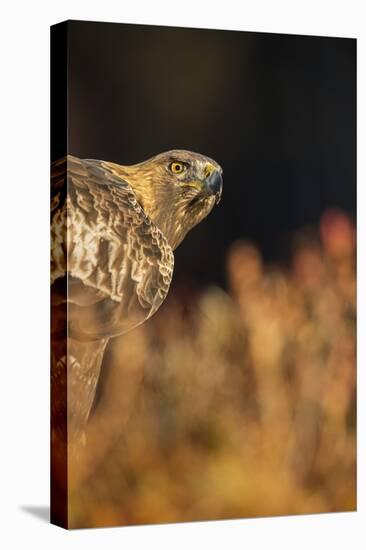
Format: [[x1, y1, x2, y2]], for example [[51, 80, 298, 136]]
[[125, 150, 223, 250]]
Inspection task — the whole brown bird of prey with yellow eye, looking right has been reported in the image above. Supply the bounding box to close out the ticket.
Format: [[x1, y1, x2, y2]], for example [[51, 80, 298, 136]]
[[51, 150, 222, 443]]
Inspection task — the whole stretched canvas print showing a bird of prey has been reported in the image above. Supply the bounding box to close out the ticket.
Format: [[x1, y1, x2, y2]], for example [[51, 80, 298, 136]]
[[51, 21, 356, 528]]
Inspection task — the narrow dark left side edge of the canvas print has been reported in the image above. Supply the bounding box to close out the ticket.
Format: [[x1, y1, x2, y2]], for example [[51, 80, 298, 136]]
[[51, 22, 68, 528]]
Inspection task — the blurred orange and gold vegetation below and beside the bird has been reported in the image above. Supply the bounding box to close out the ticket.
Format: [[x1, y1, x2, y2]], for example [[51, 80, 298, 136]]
[[69, 211, 356, 527]]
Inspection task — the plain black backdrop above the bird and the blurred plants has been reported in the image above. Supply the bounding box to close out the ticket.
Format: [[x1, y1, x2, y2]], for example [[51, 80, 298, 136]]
[[63, 18, 356, 285]]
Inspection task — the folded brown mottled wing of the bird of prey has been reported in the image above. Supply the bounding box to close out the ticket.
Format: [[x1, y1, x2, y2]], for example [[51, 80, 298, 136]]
[[51, 156, 174, 340]]
